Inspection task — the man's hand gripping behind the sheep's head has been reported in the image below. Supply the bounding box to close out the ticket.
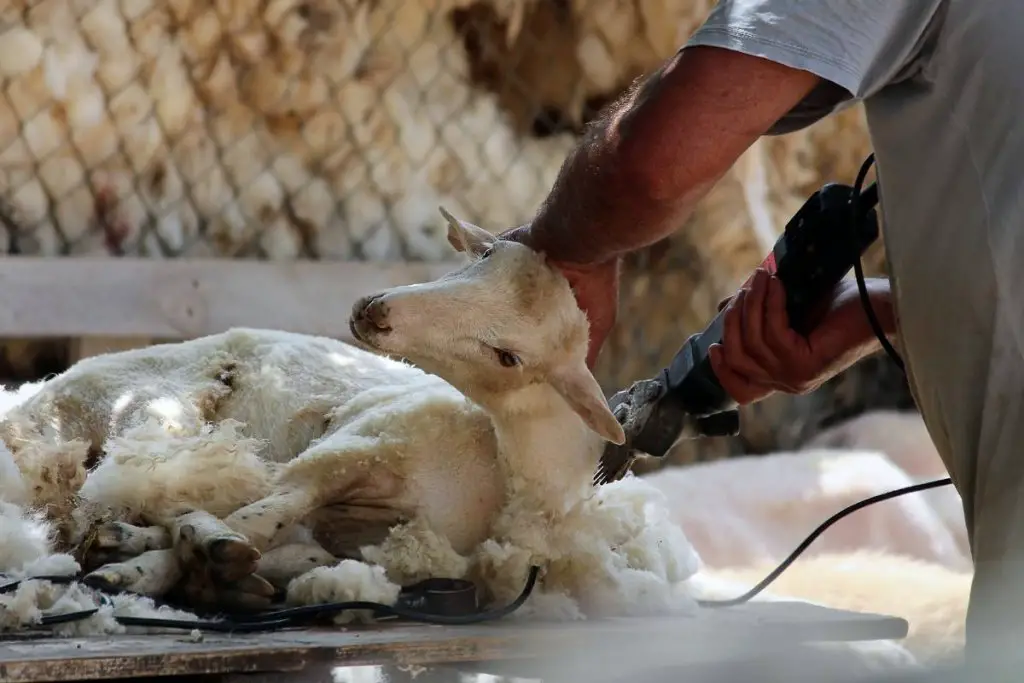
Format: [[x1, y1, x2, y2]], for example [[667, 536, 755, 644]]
[[498, 225, 622, 370]]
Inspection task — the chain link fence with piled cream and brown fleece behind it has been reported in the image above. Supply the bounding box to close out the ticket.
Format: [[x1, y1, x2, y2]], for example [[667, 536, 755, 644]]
[[0, 0, 909, 461]]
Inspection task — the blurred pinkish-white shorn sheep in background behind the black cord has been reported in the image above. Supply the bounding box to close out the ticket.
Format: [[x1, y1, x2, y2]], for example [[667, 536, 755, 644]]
[[642, 447, 971, 570]]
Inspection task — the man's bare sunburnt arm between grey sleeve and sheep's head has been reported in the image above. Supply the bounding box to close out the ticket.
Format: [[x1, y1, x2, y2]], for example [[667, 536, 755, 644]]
[[529, 47, 818, 263]]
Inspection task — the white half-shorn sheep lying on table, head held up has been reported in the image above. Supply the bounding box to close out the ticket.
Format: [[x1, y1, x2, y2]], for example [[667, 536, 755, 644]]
[[0, 208, 712, 611]]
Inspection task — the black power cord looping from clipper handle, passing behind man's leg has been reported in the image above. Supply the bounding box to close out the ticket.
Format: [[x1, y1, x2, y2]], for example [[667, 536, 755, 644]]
[[697, 154, 953, 607]]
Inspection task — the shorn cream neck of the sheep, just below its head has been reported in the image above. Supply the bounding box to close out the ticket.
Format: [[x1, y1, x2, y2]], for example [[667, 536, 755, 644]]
[[492, 384, 601, 512]]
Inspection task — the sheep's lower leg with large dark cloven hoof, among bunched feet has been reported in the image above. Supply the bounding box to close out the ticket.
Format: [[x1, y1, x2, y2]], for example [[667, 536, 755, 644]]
[[171, 511, 275, 609]]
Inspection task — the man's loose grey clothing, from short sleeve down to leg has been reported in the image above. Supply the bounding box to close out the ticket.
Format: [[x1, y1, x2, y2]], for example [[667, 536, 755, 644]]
[[688, 0, 1024, 559]]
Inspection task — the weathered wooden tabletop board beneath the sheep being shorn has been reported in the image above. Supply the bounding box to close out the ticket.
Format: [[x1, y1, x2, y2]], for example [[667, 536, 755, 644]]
[[0, 602, 907, 683]]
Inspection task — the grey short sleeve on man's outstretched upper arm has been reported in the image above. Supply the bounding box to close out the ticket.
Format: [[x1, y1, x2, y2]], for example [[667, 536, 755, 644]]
[[686, 0, 947, 132]]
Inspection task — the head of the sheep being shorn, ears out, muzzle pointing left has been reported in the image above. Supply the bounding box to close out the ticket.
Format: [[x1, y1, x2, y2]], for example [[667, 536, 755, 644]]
[[349, 209, 625, 443]]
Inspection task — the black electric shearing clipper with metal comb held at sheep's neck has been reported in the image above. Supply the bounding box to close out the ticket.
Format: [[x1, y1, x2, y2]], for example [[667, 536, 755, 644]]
[[594, 179, 879, 484]]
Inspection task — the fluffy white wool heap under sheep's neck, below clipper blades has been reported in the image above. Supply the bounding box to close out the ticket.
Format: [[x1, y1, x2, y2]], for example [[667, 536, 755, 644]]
[[476, 477, 699, 618]]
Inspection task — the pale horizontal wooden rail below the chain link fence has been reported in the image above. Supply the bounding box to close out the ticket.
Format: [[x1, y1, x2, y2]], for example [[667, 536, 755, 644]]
[[0, 256, 461, 339]]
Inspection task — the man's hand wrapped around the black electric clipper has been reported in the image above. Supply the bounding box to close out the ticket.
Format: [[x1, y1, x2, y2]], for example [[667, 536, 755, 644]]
[[709, 268, 895, 405]]
